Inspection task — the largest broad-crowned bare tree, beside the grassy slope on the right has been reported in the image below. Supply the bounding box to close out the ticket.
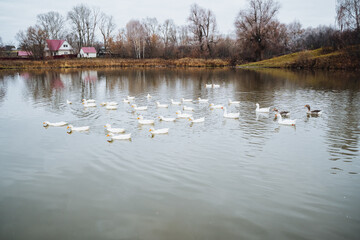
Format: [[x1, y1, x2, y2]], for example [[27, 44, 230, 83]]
[[235, 0, 280, 60]]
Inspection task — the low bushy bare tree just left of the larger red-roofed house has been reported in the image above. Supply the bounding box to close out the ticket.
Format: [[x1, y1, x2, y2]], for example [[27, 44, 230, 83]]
[[16, 25, 48, 59]]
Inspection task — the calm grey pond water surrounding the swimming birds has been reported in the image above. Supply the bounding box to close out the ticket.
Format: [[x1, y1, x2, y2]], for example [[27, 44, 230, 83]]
[[0, 69, 360, 240]]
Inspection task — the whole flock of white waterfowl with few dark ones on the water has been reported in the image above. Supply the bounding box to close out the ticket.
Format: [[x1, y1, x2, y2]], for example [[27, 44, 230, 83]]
[[43, 84, 321, 141]]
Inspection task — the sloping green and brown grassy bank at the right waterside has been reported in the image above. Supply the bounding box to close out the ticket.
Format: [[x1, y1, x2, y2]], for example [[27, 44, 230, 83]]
[[240, 45, 360, 70]]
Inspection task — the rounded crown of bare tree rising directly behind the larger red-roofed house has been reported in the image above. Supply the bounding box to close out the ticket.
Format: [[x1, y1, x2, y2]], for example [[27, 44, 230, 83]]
[[37, 12, 65, 39]]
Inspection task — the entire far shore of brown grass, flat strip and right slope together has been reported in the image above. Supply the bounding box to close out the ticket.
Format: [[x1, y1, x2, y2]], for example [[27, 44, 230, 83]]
[[0, 45, 360, 70]]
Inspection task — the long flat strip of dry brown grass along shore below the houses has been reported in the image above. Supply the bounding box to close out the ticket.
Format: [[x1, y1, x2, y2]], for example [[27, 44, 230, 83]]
[[0, 58, 229, 69]]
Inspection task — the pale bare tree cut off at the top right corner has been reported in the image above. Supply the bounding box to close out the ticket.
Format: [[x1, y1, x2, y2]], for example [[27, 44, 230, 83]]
[[336, 0, 360, 31]]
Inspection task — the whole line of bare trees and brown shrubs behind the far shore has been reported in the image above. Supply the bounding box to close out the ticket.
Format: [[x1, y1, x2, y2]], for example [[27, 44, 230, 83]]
[[7, 0, 360, 64]]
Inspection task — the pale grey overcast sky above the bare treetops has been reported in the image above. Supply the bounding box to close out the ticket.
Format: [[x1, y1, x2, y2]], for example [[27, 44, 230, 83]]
[[0, 0, 336, 44]]
